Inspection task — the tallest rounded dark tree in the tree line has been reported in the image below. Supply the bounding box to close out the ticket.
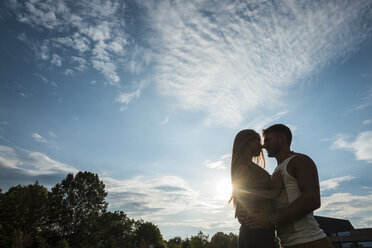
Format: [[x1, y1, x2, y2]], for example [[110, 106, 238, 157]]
[[49, 171, 107, 247]]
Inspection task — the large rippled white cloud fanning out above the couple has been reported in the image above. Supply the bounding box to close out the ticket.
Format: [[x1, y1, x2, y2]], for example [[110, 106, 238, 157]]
[[144, 1, 371, 126]]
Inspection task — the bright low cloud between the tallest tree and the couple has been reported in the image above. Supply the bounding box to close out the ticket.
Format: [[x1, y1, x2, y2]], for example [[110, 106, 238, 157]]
[[101, 173, 237, 230]]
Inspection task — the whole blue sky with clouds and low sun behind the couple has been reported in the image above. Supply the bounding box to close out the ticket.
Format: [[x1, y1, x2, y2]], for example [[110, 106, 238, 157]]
[[0, 0, 372, 239]]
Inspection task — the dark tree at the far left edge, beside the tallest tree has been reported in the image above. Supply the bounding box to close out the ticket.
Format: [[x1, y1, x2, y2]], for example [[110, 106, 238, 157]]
[[0, 181, 48, 247]]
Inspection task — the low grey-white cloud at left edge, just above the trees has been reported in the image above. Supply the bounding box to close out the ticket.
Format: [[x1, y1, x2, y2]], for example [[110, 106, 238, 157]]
[[0, 145, 78, 176]]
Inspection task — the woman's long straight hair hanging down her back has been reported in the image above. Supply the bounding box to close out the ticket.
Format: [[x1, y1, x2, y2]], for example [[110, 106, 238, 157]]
[[229, 129, 265, 207]]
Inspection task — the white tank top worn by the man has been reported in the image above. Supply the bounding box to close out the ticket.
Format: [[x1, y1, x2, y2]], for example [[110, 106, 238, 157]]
[[275, 155, 326, 246]]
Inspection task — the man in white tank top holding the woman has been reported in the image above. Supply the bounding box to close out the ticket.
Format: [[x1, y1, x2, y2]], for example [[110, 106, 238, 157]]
[[245, 124, 332, 248]]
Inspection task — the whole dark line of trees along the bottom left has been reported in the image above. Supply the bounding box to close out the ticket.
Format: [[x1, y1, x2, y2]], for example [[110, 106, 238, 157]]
[[0, 171, 237, 248]]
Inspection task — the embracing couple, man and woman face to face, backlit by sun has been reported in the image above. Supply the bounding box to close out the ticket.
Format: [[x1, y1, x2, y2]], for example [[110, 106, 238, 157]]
[[231, 124, 332, 248]]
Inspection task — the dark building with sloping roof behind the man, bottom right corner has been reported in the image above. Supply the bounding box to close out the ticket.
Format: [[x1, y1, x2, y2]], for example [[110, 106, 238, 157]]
[[315, 216, 372, 248]]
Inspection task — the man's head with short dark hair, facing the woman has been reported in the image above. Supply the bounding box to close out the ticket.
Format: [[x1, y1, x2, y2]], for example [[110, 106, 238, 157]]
[[263, 124, 292, 157]]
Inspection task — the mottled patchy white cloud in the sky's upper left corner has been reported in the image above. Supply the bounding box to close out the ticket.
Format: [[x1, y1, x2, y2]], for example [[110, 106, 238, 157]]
[[9, 0, 129, 85]]
